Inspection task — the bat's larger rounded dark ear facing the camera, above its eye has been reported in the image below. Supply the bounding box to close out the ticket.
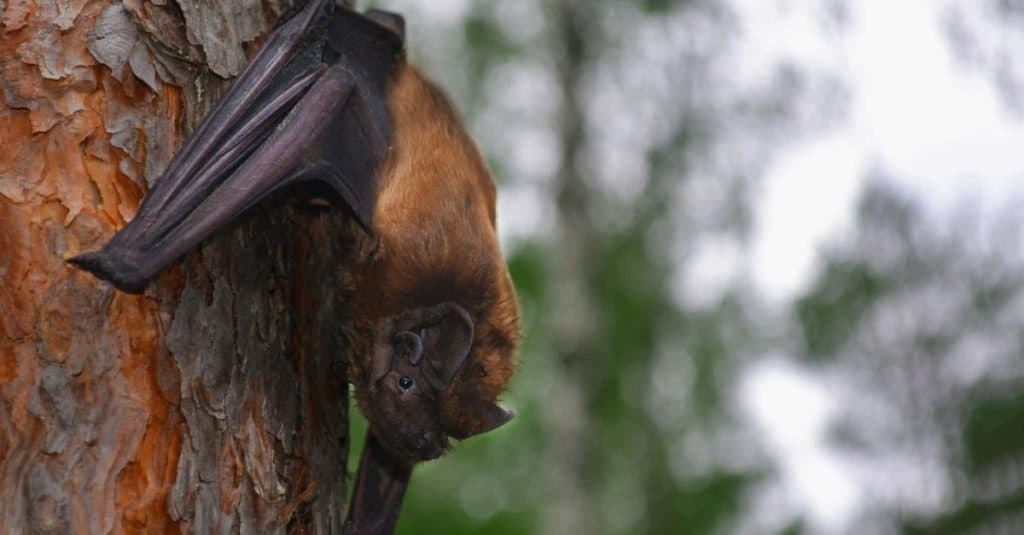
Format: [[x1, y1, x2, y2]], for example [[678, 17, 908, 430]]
[[420, 303, 473, 390]]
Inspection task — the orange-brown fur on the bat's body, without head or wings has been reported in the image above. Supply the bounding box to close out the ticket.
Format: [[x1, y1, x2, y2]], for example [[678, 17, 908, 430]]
[[350, 64, 519, 436]]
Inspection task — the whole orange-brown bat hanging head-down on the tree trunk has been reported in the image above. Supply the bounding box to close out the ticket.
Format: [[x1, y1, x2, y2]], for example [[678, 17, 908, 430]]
[[69, 0, 519, 533]]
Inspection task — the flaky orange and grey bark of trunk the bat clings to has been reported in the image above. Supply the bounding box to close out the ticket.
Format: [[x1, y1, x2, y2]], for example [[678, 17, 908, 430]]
[[0, 0, 354, 533]]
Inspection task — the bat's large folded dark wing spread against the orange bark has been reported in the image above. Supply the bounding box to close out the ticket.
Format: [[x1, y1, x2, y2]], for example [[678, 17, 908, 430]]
[[70, 0, 402, 292]]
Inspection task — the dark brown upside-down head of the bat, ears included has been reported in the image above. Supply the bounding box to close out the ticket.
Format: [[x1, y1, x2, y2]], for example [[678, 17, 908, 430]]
[[368, 302, 512, 462]]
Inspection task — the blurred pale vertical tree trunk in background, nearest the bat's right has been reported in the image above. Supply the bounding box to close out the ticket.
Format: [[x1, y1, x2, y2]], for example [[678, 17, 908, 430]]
[[541, 0, 597, 534]]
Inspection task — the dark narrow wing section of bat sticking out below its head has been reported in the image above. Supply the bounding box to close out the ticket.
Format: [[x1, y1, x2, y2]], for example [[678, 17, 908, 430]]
[[342, 434, 413, 535]]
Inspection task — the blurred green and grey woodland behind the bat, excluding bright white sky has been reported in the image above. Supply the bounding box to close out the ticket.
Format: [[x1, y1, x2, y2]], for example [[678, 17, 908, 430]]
[[349, 0, 1024, 534]]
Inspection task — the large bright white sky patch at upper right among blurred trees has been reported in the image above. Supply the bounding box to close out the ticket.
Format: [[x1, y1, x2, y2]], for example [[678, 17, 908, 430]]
[[738, 0, 1024, 302]]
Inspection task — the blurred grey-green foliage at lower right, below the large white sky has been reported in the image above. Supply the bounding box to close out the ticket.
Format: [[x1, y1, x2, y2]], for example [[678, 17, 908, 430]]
[[795, 184, 1024, 533]]
